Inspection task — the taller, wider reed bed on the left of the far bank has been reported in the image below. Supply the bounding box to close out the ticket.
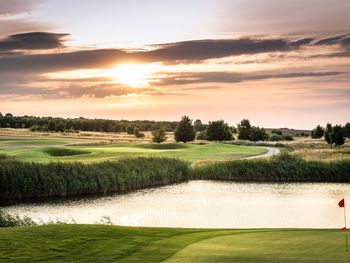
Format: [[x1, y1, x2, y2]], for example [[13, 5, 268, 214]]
[[0, 158, 189, 202]]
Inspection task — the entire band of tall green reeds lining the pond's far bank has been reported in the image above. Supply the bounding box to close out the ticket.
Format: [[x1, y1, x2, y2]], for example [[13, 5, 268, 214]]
[[0, 154, 350, 203]]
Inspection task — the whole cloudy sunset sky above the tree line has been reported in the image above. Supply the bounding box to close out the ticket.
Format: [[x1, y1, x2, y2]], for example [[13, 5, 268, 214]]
[[0, 0, 350, 129]]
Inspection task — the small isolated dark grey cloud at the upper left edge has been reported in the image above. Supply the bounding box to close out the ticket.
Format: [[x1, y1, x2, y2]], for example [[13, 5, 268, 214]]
[[0, 32, 68, 51]]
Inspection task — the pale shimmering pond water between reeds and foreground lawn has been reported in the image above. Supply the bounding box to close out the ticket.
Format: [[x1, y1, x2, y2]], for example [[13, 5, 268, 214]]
[[4, 181, 350, 228]]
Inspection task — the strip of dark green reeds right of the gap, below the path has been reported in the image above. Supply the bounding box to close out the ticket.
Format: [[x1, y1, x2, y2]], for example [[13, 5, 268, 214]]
[[191, 154, 350, 183]]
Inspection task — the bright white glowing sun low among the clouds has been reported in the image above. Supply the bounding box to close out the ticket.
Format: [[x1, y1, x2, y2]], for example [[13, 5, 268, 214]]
[[110, 64, 159, 88]]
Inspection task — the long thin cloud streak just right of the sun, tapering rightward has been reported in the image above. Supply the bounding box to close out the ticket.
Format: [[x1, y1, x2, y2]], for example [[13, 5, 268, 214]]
[[152, 71, 344, 86]]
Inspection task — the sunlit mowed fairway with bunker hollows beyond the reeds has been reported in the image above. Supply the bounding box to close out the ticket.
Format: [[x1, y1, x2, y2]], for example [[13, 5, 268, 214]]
[[0, 136, 267, 162]]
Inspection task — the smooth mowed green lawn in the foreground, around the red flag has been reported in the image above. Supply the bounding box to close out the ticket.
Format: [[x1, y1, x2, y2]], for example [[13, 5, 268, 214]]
[[0, 225, 350, 262]]
